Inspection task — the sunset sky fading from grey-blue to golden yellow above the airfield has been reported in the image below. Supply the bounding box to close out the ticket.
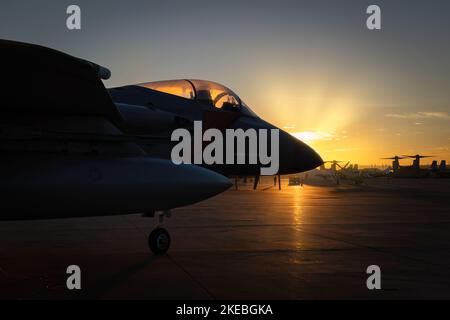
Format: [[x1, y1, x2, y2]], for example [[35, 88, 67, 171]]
[[0, 0, 450, 165]]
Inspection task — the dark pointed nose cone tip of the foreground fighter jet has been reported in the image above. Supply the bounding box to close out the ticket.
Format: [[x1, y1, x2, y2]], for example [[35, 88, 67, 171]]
[[279, 130, 323, 174]]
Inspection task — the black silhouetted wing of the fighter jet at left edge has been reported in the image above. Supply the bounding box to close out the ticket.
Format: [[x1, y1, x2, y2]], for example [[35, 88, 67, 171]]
[[0, 40, 121, 124]]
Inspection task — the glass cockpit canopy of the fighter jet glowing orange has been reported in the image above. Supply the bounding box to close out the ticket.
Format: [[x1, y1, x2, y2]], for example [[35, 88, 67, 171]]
[[138, 80, 256, 117]]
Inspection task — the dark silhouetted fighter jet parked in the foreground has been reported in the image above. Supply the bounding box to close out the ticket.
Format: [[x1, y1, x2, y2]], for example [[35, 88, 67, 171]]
[[0, 40, 322, 254]]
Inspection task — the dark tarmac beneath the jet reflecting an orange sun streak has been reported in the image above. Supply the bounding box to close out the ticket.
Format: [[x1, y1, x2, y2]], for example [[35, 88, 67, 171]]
[[0, 178, 450, 300]]
